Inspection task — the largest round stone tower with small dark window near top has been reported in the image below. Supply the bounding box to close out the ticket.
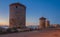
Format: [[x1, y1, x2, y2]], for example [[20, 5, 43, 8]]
[[9, 3, 26, 28]]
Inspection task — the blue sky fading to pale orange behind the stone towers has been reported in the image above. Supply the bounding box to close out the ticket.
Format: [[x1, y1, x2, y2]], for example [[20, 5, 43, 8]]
[[0, 0, 60, 25]]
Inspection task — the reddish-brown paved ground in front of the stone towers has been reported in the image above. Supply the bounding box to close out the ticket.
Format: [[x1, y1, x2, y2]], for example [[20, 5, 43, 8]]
[[0, 30, 60, 37]]
